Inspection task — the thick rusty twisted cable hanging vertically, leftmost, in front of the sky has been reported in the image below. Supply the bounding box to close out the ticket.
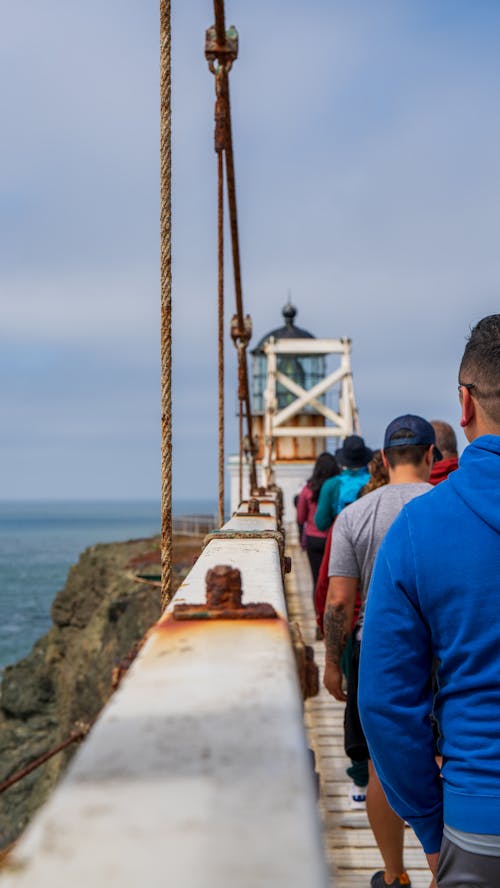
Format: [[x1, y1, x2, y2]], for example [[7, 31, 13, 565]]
[[160, 0, 172, 610]]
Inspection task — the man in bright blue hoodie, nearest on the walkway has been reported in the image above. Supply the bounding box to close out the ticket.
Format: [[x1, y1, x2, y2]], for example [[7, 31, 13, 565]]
[[359, 314, 500, 888]]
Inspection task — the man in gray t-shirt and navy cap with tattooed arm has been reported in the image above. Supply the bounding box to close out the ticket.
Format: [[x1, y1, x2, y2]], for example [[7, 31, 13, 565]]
[[324, 414, 440, 888]]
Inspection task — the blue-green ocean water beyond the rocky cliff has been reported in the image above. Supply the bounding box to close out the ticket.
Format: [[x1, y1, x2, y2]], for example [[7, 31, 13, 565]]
[[0, 500, 216, 673]]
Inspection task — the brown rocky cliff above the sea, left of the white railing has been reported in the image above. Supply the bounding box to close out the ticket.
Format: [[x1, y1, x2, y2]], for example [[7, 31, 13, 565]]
[[0, 538, 200, 848]]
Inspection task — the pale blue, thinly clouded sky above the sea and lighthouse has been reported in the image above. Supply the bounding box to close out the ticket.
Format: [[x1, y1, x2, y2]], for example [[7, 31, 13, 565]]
[[0, 0, 500, 499]]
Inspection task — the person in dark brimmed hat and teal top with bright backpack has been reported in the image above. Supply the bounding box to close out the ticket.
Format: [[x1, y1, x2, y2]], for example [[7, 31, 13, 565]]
[[314, 435, 373, 530]]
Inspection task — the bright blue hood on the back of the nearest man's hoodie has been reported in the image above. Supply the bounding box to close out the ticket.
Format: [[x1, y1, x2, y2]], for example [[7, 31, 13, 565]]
[[447, 435, 500, 533]]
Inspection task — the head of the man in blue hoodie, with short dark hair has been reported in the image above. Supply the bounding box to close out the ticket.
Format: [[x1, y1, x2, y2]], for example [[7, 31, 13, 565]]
[[458, 314, 500, 424]]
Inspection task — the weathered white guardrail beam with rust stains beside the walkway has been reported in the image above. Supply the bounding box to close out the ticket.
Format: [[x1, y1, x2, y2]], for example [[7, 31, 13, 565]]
[[0, 497, 329, 888]]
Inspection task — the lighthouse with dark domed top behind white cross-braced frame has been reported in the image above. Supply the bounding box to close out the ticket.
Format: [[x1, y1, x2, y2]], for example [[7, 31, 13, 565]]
[[228, 302, 359, 535]]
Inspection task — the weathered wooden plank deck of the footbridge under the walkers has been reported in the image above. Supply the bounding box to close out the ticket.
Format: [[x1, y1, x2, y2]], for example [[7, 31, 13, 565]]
[[287, 546, 431, 888]]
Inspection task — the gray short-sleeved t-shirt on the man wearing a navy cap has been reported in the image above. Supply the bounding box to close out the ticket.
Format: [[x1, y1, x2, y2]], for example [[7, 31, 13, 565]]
[[328, 481, 433, 626]]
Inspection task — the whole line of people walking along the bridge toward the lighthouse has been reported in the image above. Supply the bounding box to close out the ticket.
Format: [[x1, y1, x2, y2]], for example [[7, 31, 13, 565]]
[[297, 315, 500, 888]]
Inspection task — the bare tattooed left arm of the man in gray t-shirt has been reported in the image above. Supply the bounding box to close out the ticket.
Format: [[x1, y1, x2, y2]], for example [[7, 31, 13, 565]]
[[323, 577, 359, 701]]
